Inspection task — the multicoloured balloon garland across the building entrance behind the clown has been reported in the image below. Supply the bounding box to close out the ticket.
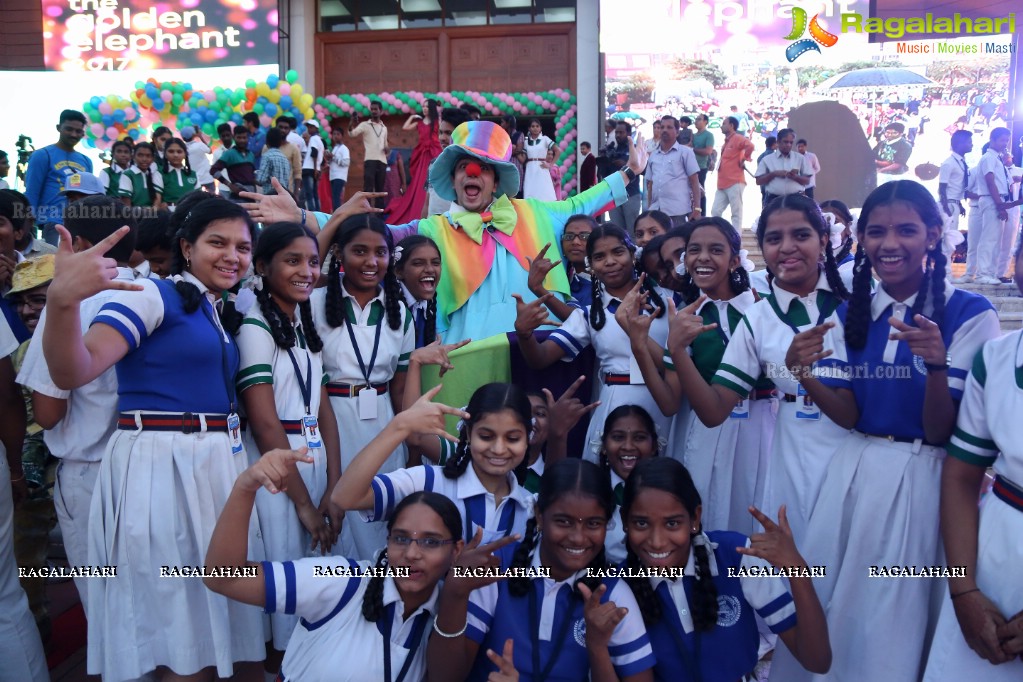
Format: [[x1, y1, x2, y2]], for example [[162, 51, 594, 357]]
[[83, 71, 577, 194]]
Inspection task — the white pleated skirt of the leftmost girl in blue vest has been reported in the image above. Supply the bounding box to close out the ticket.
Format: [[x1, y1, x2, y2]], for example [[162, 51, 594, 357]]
[[88, 423, 266, 682]]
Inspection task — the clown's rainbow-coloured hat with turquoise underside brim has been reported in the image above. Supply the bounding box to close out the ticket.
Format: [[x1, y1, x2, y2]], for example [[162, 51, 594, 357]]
[[430, 121, 519, 201]]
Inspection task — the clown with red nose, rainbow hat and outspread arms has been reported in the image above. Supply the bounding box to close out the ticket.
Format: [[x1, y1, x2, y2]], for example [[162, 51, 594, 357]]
[[248, 121, 646, 343]]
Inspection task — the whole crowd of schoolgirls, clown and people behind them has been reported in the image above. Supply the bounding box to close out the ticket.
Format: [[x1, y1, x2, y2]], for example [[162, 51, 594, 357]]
[[0, 110, 1023, 682]]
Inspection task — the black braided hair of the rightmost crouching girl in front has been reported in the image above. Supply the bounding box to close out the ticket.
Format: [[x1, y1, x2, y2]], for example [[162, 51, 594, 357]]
[[622, 457, 717, 632]]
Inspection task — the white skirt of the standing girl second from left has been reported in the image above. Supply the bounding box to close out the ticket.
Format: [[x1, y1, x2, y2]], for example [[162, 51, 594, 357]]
[[244, 429, 326, 651]]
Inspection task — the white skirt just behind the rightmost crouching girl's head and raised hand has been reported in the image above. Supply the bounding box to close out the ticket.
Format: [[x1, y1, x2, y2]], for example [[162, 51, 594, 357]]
[[682, 399, 777, 536]]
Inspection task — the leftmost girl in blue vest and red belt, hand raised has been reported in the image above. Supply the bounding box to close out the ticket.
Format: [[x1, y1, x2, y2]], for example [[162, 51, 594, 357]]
[[43, 196, 265, 680]]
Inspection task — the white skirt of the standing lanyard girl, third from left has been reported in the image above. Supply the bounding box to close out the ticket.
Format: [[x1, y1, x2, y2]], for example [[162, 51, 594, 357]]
[[330, 393, 408, 561]]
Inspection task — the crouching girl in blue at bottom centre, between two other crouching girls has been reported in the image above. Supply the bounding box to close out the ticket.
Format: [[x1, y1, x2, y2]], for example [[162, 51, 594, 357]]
[[427, 459, 655, 682]]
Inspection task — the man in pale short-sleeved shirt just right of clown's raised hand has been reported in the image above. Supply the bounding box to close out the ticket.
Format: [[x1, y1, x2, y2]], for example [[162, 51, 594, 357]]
[[646, 116, 702, 227]]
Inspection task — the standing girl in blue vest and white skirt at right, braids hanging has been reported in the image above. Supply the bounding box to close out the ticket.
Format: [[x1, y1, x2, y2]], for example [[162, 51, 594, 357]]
[[775, 180, 999, 680]]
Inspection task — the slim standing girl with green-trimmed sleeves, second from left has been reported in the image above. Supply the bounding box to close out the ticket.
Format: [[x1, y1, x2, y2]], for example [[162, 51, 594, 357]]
[[234, 221, 343, 673]]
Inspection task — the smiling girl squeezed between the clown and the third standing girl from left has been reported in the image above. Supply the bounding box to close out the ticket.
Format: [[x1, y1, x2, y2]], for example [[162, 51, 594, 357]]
[[394, 234, 441, 348]]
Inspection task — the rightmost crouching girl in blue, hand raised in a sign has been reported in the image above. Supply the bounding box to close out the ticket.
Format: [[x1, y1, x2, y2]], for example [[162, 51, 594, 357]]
[[622, 457, 831, 682]]
